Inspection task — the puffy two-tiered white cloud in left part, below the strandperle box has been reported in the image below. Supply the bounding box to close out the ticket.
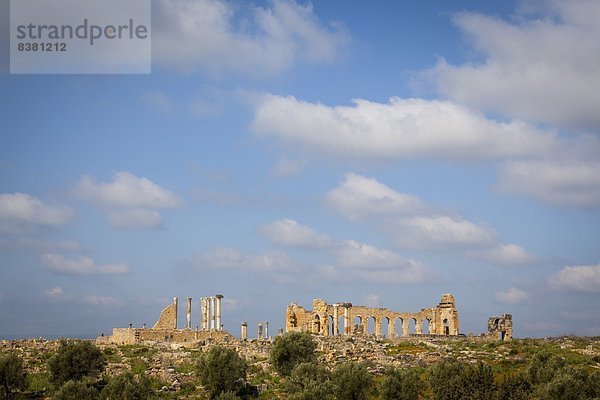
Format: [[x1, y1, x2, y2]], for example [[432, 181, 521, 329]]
[[75, 171, 181, 229]]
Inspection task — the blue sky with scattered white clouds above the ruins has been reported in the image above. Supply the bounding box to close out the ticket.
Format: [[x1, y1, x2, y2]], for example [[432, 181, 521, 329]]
[[0, 0, 600, 337]]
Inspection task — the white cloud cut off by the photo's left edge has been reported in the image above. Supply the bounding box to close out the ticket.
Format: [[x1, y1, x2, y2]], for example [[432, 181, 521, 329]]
[[0, 193, 73, 233]]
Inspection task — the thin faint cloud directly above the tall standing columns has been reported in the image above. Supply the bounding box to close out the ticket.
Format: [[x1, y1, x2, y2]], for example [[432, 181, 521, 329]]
[[193, 247, 296, 272]]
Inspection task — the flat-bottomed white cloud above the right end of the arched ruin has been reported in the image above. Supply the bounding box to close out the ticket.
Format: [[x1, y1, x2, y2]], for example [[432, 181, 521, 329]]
[[392, 215, 496, 249]]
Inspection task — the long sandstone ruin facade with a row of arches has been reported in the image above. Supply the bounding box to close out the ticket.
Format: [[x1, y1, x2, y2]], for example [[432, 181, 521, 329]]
[[285, 294, 458, 338]]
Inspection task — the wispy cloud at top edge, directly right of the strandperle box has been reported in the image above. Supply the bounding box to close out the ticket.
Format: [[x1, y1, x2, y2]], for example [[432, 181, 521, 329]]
[[152, 0, 347, 75]]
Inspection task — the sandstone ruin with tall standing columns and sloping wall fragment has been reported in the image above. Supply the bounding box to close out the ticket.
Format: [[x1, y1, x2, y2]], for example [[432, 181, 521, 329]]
[[104, 294, 233, 344]]
